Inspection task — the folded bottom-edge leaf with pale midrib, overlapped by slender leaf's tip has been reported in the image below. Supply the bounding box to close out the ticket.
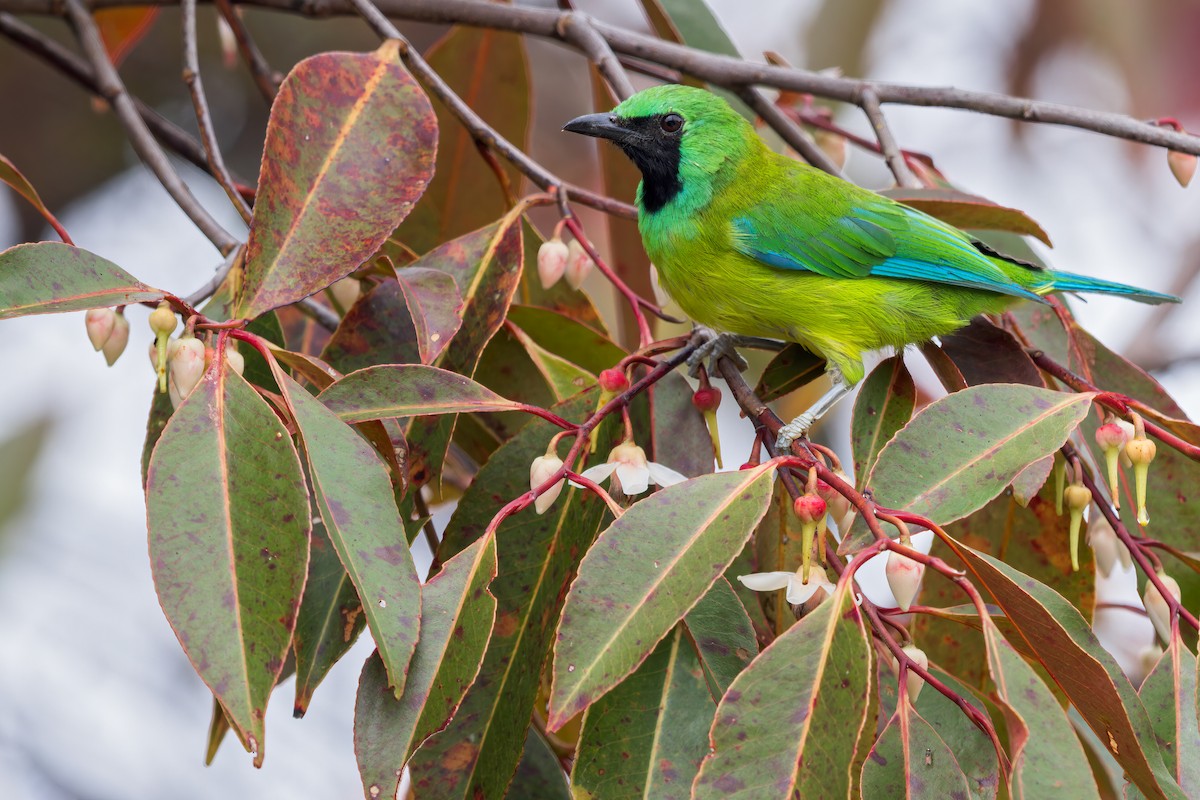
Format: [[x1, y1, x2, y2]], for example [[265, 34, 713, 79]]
[[354, 536, 496, 800]]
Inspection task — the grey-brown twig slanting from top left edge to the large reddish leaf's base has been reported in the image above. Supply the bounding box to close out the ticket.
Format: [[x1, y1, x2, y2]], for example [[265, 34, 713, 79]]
[[62, 0, 238, 255]]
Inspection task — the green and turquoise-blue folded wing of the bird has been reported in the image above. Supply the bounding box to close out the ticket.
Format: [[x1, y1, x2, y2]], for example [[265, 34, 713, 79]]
[[732, 185, 1038, 300]]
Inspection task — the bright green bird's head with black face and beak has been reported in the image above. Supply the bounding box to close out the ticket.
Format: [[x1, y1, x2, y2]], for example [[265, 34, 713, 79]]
[[563, 85, 761, 213]]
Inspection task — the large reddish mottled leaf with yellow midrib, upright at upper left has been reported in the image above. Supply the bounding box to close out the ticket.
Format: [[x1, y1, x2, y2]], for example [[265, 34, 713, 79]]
[[236, 42, 438, 318]]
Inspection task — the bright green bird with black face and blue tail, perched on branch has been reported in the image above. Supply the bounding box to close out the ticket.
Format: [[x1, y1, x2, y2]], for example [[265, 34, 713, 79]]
[[563, 85, 1178, 450]]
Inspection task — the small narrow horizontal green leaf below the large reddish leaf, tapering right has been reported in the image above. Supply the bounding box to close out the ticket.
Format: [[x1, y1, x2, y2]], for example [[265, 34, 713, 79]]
[[320, 363, 521, 422]]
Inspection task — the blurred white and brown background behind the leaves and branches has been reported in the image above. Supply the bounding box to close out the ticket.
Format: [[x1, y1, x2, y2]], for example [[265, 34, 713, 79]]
[[0, 0, 1200, 800]]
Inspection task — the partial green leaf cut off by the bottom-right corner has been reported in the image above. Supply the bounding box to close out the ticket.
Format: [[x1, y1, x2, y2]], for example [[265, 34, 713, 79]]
[[1138, 637, 1200, 798]]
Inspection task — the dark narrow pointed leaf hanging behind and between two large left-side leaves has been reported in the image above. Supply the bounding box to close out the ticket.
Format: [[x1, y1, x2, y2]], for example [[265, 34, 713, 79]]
[[292, 521, 366, 717]]
